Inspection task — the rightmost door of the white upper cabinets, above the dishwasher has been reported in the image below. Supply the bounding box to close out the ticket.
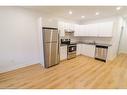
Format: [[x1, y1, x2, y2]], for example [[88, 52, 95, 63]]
[[98, 22, 113, 37]]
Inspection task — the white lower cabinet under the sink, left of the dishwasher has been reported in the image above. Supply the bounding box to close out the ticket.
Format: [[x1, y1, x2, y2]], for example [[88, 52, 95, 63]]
[[77, 44, 95, 57]]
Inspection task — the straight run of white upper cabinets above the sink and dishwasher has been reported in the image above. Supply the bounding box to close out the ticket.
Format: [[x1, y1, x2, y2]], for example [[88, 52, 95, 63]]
[[74, 21, 113, 37]]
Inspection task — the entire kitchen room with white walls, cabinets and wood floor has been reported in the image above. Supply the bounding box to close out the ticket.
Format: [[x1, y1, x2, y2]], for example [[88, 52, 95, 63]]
[[0, 6, 127, 88]]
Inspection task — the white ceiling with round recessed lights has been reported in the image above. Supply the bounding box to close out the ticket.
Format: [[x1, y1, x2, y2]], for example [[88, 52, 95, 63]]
[[24, 6, 127, 22]]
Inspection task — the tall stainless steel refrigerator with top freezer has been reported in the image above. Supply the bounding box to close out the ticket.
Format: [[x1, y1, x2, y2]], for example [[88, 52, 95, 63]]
[[42, 27, 60, 68]]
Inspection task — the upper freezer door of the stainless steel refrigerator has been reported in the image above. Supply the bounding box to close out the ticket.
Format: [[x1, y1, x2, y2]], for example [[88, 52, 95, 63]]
[[43, 29, 58, 43]]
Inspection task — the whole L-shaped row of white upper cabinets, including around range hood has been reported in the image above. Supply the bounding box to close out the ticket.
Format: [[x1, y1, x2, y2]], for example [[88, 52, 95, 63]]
[[58, 21, 113, 37]]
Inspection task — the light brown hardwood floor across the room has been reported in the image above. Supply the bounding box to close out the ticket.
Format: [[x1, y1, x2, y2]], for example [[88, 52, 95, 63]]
[[0, 54, 127, 89]]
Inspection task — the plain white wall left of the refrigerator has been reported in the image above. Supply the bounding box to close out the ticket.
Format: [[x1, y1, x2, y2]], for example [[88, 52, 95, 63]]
[[0, 7, 43, 73]]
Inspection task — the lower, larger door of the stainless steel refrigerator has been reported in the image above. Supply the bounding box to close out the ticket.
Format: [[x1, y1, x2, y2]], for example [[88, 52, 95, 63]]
[[44, 43, 59, 68]]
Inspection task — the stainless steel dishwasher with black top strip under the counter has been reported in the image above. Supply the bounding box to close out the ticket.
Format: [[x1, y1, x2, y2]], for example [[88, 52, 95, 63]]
[[95, 45, 108, 62]]
